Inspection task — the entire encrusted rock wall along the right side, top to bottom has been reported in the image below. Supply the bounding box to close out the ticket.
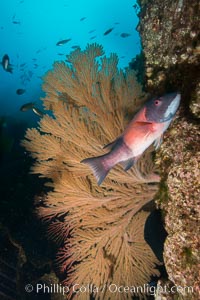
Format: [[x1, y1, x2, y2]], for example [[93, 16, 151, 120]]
[[138, 0, 200, 299]]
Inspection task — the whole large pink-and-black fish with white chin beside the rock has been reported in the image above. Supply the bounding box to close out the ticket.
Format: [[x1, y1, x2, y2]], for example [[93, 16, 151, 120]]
[[82, 93, 180, 185]]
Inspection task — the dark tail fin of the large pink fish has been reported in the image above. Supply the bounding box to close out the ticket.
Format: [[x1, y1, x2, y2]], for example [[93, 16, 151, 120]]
[[81, 154, 112, 185]]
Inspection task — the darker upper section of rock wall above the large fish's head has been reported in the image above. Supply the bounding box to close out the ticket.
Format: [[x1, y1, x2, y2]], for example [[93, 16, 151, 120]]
[[138, 0, 200, 116]]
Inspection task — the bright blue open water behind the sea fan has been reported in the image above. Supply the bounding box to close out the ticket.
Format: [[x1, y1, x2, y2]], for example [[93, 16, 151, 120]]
[[0, 0, 141, 121]]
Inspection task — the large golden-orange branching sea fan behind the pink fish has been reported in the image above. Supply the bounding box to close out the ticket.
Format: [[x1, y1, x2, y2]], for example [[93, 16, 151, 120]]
[[23, 44, 159, 299]]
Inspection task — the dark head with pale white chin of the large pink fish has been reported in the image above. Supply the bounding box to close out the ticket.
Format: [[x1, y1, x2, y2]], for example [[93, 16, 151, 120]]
[[145, 93, 181, 123]]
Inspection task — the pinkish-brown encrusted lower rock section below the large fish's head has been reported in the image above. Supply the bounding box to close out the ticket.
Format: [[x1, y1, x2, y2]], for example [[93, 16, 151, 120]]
[[157, 117, 200, 299]]
